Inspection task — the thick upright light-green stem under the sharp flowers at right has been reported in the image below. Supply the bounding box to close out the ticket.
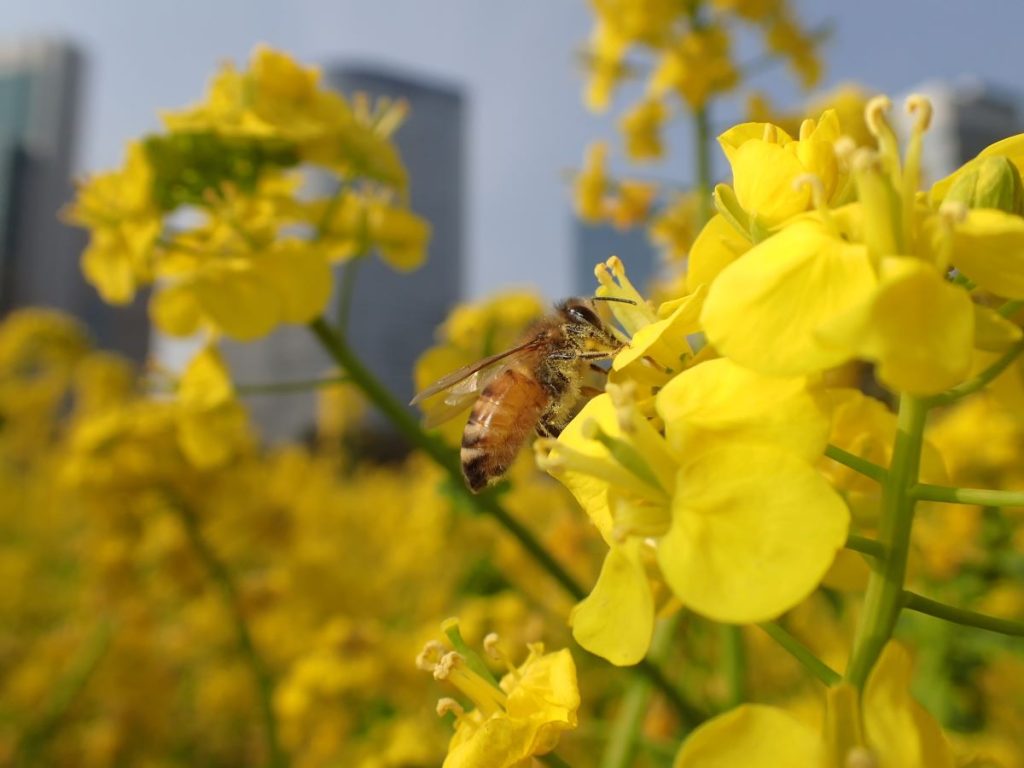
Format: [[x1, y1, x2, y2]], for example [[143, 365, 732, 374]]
[[846, 394, 928, 688]]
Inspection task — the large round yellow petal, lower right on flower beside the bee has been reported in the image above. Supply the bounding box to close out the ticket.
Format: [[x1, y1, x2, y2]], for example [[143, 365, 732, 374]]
[[657, 444, 849, 624]]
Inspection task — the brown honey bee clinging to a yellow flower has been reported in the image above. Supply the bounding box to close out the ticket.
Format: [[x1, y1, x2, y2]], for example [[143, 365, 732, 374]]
[[410, 296, 633, 494]]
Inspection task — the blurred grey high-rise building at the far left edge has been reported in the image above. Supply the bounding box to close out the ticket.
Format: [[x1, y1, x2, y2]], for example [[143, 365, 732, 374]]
[[0, 41, 150, 360]]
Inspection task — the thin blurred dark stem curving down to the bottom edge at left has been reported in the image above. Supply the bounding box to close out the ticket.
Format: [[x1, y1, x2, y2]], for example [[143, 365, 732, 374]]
[[170, 503, 288, 768]]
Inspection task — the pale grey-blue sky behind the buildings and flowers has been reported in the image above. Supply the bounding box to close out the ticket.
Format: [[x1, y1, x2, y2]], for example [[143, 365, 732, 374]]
[[6, 0, 1024, 297]]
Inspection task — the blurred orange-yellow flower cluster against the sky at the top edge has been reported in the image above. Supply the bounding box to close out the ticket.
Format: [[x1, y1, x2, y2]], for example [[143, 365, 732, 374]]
[[574, 0, 823, 301]]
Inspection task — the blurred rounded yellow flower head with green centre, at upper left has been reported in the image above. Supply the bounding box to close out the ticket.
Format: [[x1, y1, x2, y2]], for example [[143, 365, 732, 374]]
[[67, 47, 430, 348]]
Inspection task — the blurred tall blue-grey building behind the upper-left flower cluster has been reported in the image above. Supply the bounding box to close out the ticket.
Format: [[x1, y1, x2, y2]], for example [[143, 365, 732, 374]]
[[226, 67, 466, 441]]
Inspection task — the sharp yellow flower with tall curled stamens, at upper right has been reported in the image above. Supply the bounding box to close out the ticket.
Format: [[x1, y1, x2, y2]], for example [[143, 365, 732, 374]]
[[701, 97, 1003, 395]]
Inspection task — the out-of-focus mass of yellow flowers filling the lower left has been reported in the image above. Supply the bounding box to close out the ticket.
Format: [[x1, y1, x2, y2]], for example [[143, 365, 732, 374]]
[[0, 309, 601, 768]]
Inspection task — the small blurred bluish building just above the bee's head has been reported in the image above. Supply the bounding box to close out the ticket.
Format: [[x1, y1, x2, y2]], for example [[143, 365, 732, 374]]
[[572, 219, 657, 296]]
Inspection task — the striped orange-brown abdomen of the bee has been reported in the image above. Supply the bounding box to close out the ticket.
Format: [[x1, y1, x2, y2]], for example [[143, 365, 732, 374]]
[[460, 369, 550, 492]]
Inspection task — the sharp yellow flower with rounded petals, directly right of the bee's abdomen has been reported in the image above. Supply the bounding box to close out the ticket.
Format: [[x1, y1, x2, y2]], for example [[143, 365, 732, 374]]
[[538, 259, 848, 664]]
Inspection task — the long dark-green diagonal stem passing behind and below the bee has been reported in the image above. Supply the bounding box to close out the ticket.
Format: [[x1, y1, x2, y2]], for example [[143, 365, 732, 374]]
[[309, 317, 706, 725]]
